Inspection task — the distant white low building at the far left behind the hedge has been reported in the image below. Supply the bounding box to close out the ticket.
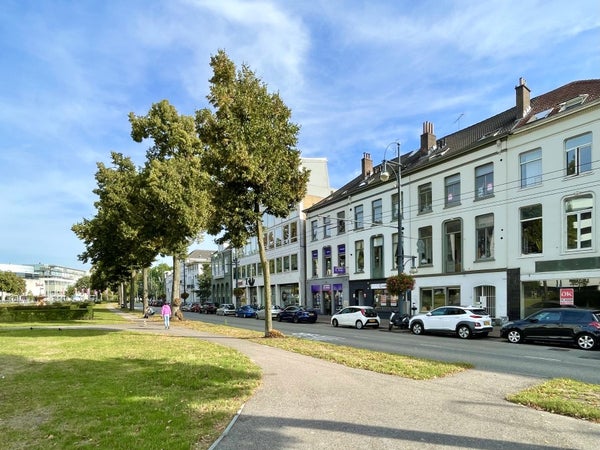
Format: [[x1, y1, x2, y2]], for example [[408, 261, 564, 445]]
[[0, 264, 90, 301]]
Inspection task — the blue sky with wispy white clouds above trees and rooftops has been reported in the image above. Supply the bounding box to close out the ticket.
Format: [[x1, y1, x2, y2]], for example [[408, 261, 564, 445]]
[[0, 0, 600, 269]]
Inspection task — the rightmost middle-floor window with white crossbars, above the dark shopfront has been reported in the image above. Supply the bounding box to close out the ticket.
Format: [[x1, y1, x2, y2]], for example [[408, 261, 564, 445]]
[[565, 194, 593, 250]]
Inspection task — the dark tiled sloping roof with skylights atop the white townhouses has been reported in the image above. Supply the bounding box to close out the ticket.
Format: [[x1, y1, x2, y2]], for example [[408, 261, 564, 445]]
[[305, 79, 600, 212]]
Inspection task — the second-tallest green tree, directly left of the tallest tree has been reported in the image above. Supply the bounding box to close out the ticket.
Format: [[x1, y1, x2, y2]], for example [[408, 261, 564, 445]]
[[129, 100, 211, 317]]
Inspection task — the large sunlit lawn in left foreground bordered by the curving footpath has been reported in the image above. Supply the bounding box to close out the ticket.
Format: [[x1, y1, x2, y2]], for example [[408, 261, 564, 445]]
[[0, 322, 261, 449]]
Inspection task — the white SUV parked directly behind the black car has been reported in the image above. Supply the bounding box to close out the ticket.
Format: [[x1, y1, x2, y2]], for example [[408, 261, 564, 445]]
[[408, 306, 494, 339]]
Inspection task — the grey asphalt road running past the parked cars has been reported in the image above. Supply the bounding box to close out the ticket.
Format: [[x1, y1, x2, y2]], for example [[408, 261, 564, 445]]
[[185, 313, 600, 384]]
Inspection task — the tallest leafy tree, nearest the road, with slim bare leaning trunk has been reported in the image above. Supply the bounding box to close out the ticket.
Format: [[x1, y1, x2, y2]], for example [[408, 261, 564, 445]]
[[196, 50, 309, 337]]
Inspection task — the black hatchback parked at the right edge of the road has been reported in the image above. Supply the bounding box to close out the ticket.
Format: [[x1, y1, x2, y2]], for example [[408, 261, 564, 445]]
[[500, 308, 600, 350]]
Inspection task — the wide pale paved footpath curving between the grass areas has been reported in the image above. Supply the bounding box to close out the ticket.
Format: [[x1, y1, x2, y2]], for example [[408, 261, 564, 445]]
[[111, 315, 600, 450]]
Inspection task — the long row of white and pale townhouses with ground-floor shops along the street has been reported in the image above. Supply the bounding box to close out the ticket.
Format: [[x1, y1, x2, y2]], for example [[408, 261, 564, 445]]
[[212, 79, 600, 319]]
